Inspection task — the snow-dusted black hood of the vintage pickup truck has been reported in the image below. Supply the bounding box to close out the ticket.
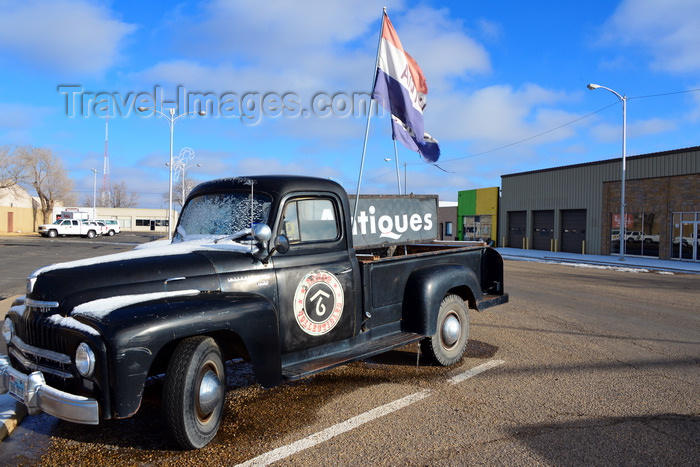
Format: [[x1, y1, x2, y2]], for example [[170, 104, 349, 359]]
[[27, 242, 250, 316]]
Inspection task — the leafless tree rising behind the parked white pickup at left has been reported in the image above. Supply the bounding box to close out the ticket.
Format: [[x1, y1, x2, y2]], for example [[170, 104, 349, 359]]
[[15, 146, 73, 223]]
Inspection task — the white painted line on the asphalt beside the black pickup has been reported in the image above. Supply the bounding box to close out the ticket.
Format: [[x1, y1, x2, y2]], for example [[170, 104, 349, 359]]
[[237, 360, 504, 467]]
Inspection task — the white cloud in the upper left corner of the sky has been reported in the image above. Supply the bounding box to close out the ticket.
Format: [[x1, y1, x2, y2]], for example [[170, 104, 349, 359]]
[[0, 0, 136, 75]]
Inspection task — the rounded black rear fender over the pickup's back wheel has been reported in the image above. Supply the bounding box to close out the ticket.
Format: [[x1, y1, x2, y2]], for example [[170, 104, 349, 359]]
[[403, 264, 482, 336]]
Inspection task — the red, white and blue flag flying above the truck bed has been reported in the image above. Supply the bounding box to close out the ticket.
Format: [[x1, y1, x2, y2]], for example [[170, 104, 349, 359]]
[[372, 14, 440, 162]]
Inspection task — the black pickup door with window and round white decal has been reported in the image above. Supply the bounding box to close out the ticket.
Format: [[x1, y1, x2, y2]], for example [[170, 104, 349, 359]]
[[273, 195, 359, 354]]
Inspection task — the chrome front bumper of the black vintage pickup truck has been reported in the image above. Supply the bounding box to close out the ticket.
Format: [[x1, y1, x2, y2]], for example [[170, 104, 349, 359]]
[[0, 355, 100, 425]]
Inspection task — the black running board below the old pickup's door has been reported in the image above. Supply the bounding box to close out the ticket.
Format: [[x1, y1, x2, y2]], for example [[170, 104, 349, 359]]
[[282, 332, 425, 380]]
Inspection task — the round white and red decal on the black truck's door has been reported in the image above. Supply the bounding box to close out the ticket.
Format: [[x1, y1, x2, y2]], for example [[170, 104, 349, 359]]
[[294, 270, 345, 336]]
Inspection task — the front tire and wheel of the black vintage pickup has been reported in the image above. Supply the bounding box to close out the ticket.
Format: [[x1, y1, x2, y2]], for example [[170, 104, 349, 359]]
[[163, 336, 226, 449]]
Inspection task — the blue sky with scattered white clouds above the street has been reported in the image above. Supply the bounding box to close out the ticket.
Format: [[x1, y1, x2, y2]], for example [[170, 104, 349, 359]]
[[0, 0, 700, 207]]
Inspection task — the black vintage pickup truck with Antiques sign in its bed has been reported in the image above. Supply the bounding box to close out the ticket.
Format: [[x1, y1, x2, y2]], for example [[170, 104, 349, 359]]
[[0, 176, 508, 449]]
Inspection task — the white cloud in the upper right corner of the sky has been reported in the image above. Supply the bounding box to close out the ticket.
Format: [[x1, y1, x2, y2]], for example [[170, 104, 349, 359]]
[[603, 0, 700, 73]]
